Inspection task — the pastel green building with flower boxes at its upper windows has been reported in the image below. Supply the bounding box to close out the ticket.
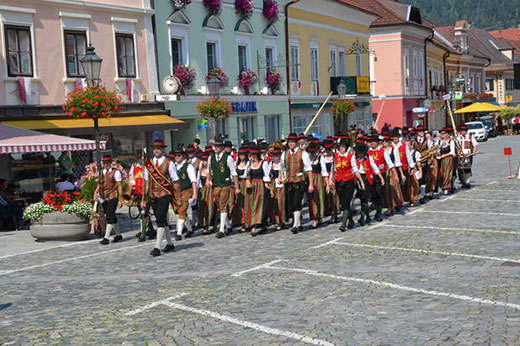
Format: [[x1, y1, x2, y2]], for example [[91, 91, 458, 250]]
[[155, 0, 289, 147]]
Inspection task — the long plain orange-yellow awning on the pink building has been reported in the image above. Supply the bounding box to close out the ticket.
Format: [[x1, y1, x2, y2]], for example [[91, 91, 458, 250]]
[[2, 114, 184, 130]]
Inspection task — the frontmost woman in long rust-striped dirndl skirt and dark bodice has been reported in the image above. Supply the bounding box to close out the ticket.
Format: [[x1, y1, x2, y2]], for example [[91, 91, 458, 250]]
[[244, 145, 270, 237]]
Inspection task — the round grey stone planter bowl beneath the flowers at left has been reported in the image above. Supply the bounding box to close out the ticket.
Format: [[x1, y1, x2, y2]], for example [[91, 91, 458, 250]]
[[30, 212, 90, 240]]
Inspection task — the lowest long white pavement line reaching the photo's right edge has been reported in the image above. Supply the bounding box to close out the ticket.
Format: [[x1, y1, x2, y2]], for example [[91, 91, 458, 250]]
[[268, 267, 520, 310]]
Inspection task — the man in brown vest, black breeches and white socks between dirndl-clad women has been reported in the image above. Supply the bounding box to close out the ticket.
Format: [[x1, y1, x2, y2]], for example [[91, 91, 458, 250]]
[[282, 133, 314, 234]]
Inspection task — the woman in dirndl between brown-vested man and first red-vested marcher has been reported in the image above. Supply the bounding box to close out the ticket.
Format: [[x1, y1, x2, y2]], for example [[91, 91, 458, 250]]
[[307, 142, 330, 229]]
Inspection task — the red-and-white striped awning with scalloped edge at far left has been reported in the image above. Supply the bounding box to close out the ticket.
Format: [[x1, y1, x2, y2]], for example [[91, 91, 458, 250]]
[[0, 124, 105, 154]]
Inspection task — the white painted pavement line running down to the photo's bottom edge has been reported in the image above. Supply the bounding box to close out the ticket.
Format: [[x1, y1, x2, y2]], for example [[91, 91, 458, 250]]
[[163, 301, 334, 346]]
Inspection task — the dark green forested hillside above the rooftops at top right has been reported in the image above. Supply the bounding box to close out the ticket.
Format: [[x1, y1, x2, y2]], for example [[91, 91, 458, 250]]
[[399, 0, 520, 31]]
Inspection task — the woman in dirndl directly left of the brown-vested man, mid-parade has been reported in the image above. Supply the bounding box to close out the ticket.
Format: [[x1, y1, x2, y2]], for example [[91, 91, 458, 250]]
[[269, 147, 287, 231]]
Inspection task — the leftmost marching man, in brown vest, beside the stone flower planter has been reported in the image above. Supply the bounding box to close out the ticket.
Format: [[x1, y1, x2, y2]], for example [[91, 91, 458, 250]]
[[94, 154, 123, 245]]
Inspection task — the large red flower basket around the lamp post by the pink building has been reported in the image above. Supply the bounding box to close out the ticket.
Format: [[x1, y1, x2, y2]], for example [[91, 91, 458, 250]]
[[63, 86, 122, 119]]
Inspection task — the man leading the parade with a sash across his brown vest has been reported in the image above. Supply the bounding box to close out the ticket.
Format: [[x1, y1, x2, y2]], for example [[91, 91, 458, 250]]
[[141, 140, 180, 256]]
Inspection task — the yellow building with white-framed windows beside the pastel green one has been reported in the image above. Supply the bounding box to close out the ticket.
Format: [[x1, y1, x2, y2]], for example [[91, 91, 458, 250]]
[[288, 0, 377, 138]]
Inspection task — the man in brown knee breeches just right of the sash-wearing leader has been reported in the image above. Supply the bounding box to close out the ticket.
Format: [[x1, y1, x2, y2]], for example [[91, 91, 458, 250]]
[[174, 150, 198, 241]]
